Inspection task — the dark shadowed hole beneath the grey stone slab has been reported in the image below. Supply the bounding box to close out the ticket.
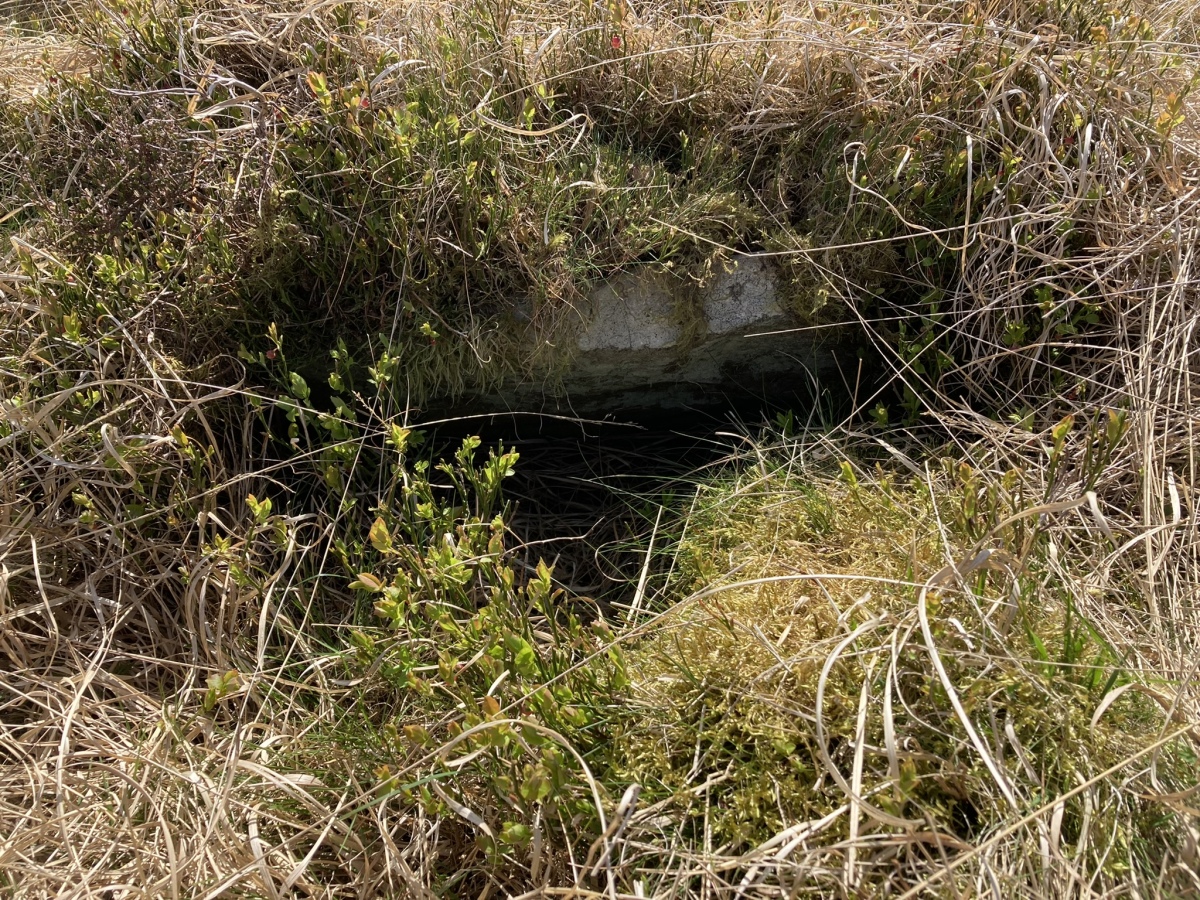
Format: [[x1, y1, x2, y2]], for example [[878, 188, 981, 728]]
[[431, 384, 848, 612]]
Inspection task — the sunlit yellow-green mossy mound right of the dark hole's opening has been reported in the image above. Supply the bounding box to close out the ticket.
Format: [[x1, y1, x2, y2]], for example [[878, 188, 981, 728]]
[[613, 446, 1196, 889]]
